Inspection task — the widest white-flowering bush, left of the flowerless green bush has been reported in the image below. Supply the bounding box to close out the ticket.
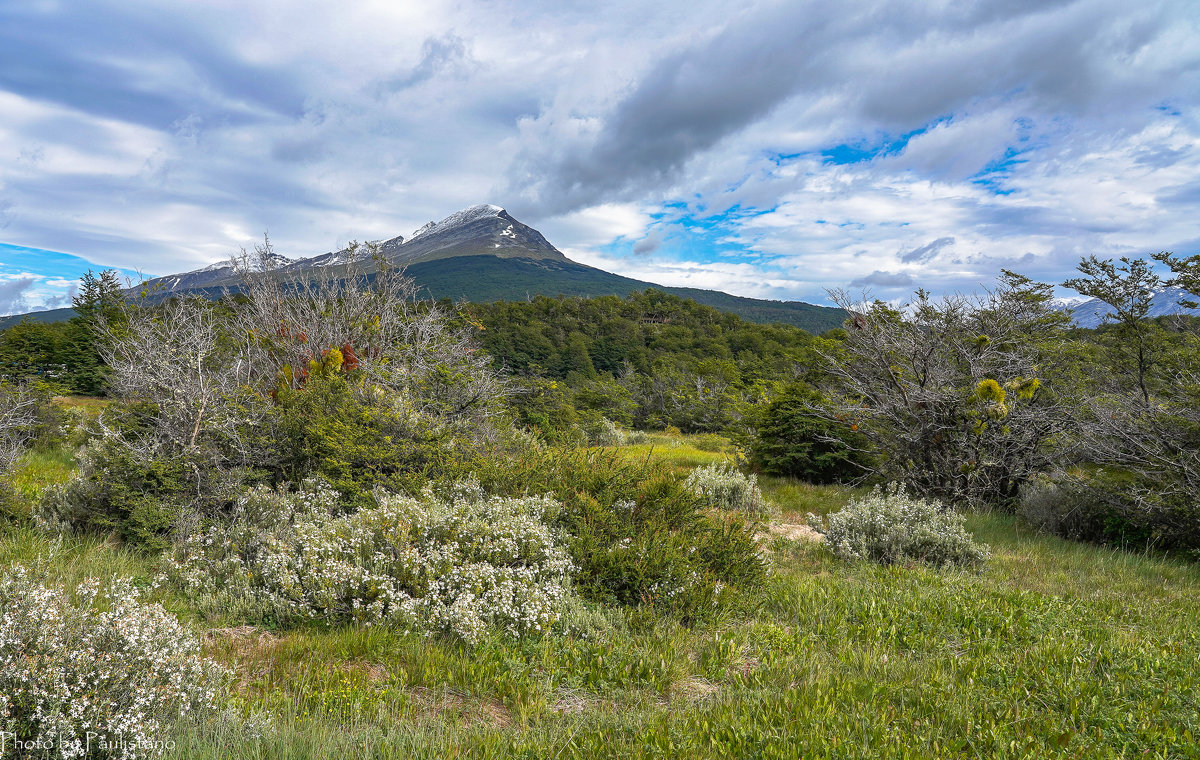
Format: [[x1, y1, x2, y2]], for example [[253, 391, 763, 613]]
[[170, 481, 572, 642]]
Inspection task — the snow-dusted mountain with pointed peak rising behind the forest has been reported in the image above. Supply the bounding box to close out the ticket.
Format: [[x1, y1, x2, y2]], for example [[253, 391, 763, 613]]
[[0, 205, 845, 333]]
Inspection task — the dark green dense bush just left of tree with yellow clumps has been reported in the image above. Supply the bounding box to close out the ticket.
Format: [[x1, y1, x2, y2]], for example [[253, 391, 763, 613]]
[[749, 383, 869, 483]]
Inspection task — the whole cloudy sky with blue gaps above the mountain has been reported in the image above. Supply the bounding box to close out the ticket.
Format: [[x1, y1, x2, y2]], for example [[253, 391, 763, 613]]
[[0, 0, 1200, 313]]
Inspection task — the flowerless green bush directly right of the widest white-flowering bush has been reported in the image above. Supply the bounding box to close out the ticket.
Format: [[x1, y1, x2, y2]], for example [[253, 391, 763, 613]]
[[480, 448, 766, 621]]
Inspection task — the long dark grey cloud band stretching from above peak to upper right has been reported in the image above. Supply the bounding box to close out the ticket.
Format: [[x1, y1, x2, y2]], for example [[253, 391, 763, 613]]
[[512, 0, 1198, 214]]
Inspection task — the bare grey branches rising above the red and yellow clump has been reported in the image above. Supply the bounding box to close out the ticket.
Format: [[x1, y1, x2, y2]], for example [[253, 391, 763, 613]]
[[234, 240, 509, 426]]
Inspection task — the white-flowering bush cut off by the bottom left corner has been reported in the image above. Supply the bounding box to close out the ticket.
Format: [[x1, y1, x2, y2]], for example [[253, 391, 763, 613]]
[[0, 565, 223, 760]]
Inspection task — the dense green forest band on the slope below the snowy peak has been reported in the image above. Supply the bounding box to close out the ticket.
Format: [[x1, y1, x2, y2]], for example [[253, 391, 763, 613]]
[[468, 291, 830, 435]]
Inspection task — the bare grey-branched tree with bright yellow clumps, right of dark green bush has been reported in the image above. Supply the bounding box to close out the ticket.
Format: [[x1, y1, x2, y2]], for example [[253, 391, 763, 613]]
[[812, 271, 1073, 503]]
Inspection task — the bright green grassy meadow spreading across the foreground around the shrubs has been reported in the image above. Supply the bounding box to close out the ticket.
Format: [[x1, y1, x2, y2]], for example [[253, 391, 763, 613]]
[[0, 437, 1200, 760]]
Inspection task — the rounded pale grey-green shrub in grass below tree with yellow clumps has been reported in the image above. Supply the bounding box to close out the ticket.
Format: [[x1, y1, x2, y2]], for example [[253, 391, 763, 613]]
[[824, 484, 989, 565]]
